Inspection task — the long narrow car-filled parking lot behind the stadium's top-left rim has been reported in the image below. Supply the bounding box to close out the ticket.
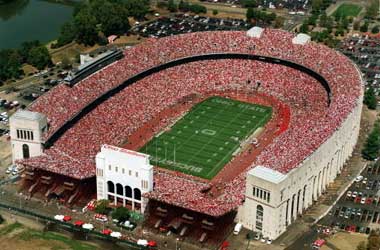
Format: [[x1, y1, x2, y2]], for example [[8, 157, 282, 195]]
[[132, 14, 251, 37]]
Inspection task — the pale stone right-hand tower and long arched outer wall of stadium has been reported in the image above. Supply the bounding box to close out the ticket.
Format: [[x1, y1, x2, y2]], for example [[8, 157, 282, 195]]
[[238, 91, 363, 239]]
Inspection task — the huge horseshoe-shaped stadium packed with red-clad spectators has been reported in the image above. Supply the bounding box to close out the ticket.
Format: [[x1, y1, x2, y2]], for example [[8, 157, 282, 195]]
[[10, 27, 363, 241]]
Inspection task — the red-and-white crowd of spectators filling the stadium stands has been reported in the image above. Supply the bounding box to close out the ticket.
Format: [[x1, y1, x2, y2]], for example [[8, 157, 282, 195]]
[[21, 29, 362, 216]]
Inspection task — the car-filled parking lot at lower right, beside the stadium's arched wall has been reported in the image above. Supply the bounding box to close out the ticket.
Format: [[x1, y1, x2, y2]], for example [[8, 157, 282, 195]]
[[321, 160, 380, 234]]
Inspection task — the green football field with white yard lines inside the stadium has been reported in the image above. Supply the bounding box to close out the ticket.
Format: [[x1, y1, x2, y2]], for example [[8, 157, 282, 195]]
[[140, 97, 272, 179]]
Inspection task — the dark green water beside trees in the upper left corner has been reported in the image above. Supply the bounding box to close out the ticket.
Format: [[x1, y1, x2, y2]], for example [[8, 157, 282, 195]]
[[0, 0, 73, 49]]
